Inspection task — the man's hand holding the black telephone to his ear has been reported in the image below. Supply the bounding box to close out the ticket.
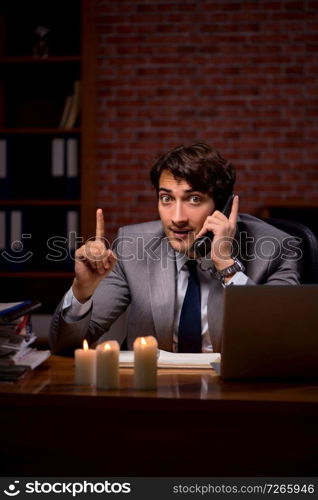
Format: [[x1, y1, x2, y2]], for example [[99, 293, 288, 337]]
[[197, 196, 239, 271]]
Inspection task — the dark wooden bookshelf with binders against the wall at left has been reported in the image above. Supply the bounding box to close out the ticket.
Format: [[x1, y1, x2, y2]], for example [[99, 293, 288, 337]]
[[0, 0, 95, 313]]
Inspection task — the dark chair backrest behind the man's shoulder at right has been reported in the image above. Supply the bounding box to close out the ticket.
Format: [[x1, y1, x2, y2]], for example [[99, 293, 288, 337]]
[[264, 217, 318, 284]]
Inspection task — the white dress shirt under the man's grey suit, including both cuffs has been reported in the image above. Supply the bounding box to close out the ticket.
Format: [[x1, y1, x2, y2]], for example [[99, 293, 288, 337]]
[[63, 253, 248, 352]]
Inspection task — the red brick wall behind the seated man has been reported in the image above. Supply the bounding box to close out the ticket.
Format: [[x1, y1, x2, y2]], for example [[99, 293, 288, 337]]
[[95, 0, 318, 239]]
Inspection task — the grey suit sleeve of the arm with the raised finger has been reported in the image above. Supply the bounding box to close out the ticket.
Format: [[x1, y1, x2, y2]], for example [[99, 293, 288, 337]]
[[49, 230, 131, 354]]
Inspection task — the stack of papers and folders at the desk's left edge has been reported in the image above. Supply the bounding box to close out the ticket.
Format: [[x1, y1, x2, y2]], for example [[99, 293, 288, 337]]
[[0, 301, 50, 381]]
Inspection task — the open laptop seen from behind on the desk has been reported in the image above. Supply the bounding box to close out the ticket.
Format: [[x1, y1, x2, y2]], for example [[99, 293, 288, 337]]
[[217, 285, 318, 379]]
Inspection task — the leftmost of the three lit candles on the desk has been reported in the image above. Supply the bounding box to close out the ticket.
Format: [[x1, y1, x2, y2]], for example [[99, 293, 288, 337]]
[[96, 340, 119, 389]]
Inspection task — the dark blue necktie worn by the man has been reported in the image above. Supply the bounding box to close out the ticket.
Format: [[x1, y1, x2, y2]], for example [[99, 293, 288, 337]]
[[178, 260, 202, 352]]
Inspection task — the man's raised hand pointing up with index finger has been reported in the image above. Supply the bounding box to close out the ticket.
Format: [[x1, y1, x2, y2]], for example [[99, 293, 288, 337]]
[[72, 208, 117, 302]]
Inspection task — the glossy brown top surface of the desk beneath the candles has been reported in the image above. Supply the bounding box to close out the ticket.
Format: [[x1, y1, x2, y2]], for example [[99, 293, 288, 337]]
[[0, 356, 318, 405]]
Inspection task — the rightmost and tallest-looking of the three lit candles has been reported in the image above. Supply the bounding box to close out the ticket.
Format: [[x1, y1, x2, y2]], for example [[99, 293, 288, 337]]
[[134, 336, 158, 390]]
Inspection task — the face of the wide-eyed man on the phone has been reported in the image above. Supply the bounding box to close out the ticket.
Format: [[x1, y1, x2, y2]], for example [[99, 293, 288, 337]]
[[158, 170, 215, 253]]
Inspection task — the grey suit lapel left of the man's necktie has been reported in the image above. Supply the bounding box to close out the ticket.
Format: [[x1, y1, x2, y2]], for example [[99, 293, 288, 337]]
[[147, 237, 176, 351]]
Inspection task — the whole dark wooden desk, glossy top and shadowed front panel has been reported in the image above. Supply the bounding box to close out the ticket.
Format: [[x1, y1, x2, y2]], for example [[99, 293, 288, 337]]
[[0, 356, 318, 477]]
